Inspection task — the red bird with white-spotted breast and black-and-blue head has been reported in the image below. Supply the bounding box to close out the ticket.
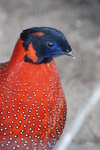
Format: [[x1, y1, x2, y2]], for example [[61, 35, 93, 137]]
[[0, 27, 74, 150]]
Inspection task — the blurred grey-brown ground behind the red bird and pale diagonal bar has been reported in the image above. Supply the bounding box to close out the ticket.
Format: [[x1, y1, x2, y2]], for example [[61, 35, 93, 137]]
[[0, 0, 100, 150]]
